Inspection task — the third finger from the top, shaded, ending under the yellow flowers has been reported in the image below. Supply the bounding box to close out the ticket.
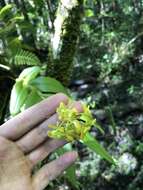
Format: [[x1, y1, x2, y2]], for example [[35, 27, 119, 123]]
[[27, 139, 66, 168]]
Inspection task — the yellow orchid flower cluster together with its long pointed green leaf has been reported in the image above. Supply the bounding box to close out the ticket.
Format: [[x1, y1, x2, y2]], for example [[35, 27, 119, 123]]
[[48, 103, 115, 164]]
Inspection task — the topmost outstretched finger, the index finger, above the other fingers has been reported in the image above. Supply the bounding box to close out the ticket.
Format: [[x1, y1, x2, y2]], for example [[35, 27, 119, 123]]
[[0, 93, 68, 140]]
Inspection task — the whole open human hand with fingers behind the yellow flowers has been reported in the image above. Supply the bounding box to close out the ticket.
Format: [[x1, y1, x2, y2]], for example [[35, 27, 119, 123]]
[[0, 93, 82, 190]]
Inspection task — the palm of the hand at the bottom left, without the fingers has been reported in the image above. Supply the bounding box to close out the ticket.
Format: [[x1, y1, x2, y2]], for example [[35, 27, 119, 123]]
[[0, 137, 33, 190]]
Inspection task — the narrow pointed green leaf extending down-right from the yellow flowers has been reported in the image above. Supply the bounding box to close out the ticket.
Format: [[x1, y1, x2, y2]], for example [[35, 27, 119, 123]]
[[82, 133, 115, 164]]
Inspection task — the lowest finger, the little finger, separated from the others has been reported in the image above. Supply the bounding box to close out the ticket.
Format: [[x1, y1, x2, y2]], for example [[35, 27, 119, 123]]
[[33, 152, 77, 190]]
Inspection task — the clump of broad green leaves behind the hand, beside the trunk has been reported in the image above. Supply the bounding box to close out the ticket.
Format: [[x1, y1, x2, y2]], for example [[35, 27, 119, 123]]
[[10, 66, 66, 116]]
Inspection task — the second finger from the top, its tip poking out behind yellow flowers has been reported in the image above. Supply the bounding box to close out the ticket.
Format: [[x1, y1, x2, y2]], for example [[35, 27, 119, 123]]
[[17, 102, 82, 153]]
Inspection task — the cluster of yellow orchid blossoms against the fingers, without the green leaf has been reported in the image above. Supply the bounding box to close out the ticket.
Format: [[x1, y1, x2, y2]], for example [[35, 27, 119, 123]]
[[48, 103, 96, 142]]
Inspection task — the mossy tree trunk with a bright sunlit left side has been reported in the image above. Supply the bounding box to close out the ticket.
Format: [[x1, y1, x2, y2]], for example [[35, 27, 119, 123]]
[[47, 0, 83, 86]]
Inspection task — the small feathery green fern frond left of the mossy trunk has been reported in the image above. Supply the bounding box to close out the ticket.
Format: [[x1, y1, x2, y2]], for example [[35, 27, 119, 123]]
[[14, 49, 40, 66]]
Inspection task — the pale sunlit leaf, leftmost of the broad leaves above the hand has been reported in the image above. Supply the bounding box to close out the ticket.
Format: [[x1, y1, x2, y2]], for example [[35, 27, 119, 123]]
[[10, 81, 29, 116]]
